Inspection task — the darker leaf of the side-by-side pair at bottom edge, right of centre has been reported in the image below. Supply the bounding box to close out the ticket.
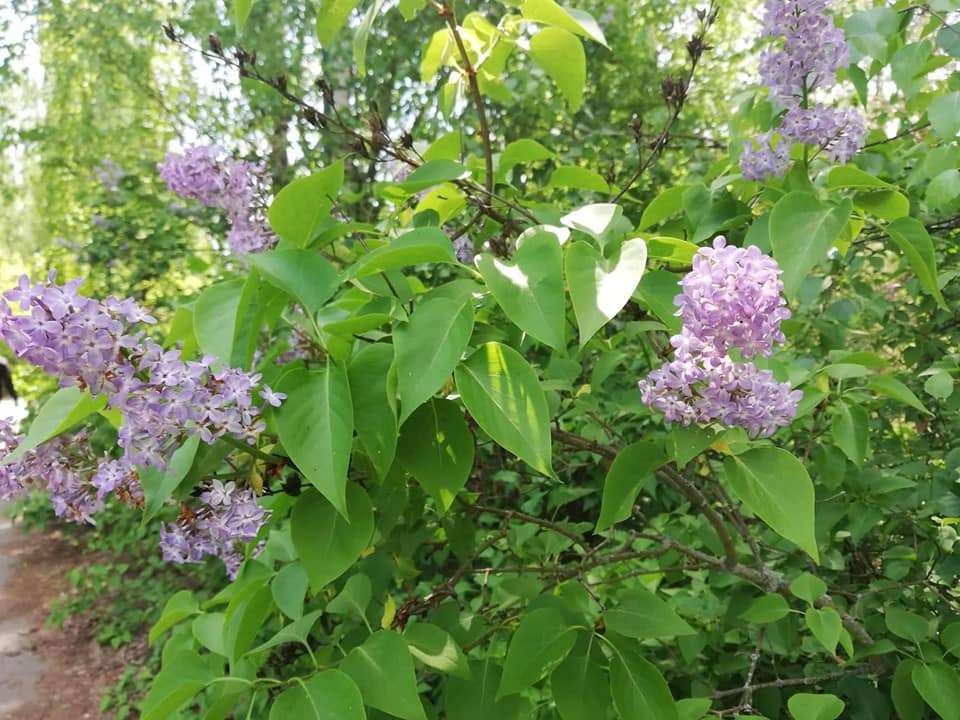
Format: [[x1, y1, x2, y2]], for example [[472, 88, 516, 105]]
[[550, 642, 610, 720]]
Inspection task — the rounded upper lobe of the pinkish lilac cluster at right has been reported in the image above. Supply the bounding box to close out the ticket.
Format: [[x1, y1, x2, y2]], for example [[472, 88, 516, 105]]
[[673, 236, 790, 358]]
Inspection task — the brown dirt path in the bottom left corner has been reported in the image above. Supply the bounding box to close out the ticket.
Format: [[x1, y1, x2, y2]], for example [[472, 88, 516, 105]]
[[0, 516, 130, 720]]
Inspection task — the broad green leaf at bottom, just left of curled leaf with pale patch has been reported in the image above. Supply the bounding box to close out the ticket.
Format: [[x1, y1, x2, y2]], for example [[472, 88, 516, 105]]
[[340, 630, 427, 720]]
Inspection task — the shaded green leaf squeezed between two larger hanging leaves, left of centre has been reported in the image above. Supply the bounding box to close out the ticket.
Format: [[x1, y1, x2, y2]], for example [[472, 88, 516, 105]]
[[347, 342, 398, 479]]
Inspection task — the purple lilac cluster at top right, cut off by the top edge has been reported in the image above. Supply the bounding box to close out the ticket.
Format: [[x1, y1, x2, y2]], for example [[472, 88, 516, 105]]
[[740, 0, 866, 180]]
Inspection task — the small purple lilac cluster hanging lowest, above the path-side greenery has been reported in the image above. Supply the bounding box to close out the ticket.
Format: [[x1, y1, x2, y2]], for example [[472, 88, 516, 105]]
[[160, 480, 270, 579]]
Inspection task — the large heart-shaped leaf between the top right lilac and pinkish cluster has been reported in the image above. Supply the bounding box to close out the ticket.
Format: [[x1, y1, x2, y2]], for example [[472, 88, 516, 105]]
[[770, 192, 853, 299]]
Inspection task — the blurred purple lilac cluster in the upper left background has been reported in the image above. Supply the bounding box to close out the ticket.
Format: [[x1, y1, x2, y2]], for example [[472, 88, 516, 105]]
[[157, 145, 277, 254]]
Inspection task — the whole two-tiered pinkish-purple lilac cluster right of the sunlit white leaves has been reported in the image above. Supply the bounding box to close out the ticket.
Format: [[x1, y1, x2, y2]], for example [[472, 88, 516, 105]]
[[640, 237, 802, 437]]
